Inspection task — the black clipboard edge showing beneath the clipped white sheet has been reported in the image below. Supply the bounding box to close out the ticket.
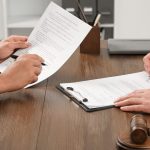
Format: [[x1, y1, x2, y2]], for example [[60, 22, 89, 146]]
[[56, 85, 115, 112]]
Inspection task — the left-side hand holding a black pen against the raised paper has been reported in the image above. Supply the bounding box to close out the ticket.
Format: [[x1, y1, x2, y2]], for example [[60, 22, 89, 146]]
[[0, 54, 43, 93]]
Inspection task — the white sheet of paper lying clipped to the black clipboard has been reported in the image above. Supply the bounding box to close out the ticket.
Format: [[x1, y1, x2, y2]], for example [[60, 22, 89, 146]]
[[60, 72, 150, 108]]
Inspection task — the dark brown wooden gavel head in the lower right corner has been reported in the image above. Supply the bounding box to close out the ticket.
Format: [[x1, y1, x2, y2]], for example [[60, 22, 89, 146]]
[[130, 115, 148, 144]]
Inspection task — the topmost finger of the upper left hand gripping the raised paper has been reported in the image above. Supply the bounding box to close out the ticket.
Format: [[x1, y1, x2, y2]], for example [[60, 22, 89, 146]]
[[5, 35, 28, 42]]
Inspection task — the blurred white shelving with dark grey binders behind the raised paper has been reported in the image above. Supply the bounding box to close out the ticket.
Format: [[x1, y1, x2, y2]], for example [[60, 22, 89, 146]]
[[0, 0, 114, 39]]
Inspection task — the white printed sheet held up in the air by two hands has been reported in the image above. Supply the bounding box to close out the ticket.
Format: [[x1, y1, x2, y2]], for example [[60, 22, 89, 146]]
[[0, 2, 91, 86]]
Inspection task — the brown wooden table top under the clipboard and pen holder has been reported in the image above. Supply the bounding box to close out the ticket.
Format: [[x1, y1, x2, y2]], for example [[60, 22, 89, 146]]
[[0, 42, 149, 150]]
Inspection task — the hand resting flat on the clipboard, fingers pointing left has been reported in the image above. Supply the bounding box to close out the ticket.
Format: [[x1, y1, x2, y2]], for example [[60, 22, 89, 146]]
[[115, 89, 150, 113]]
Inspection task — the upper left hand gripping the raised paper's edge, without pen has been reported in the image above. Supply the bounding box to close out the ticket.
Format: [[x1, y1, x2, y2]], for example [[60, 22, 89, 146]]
[[0, 35, 30, 62]]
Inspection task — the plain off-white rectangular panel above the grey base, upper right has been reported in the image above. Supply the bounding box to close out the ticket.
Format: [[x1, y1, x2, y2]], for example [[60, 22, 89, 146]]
[[114, 0, 150, 39]]
